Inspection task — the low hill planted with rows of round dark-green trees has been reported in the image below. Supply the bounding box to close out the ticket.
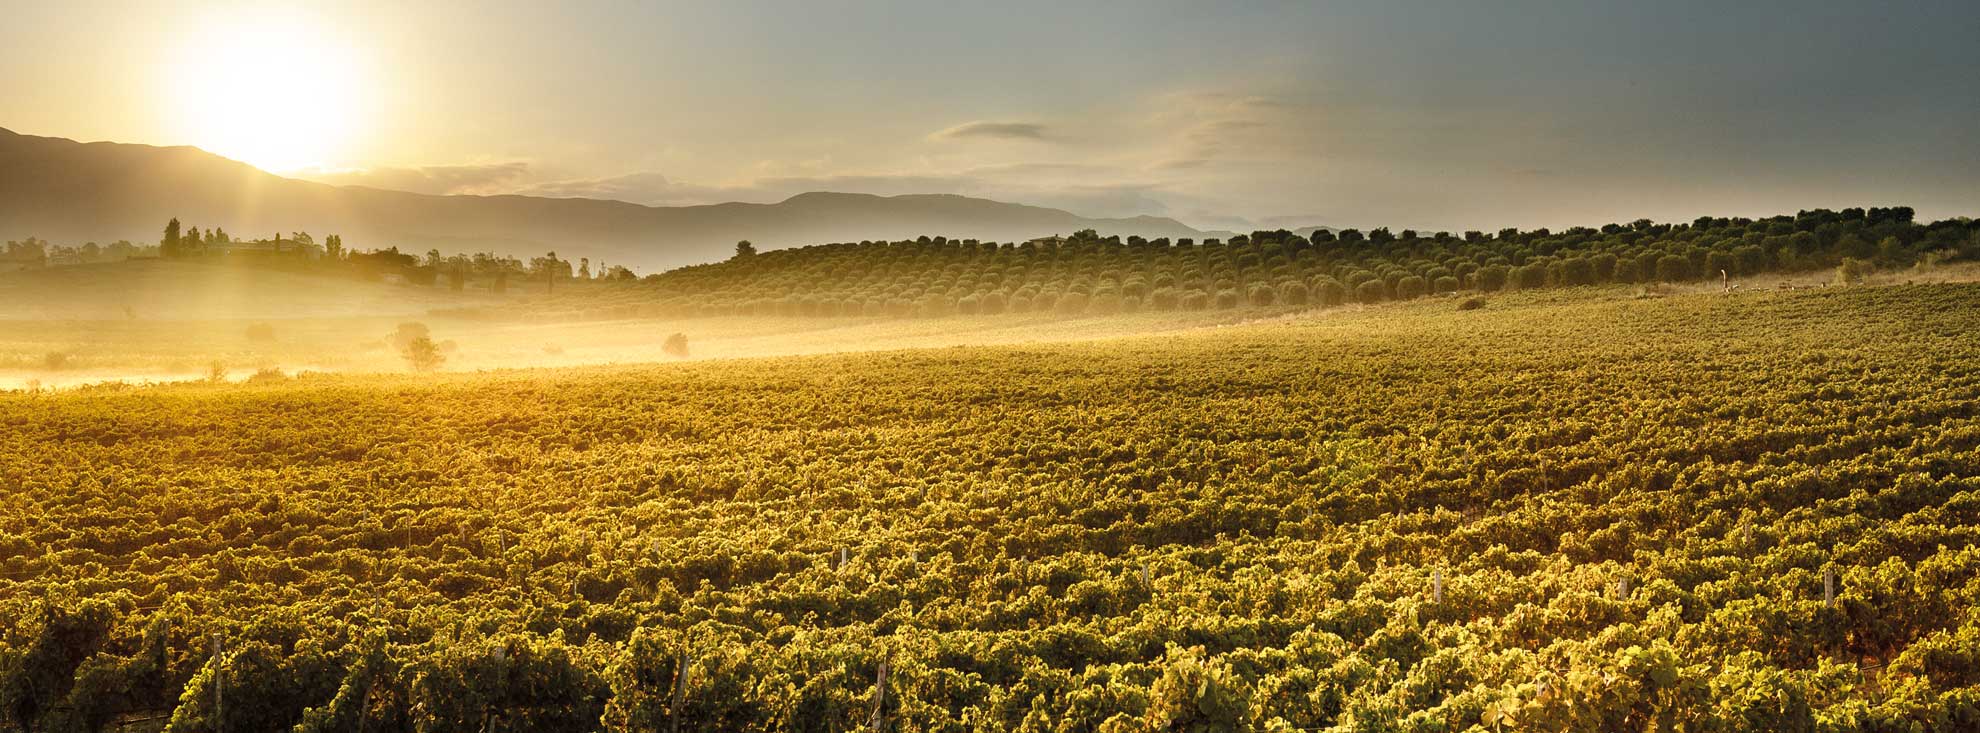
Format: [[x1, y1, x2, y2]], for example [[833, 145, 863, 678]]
[[625, 206, 1980, 317]]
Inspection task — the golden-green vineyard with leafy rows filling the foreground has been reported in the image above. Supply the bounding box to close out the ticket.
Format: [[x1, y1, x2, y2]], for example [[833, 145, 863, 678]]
[[0, 283, 1980, 733]]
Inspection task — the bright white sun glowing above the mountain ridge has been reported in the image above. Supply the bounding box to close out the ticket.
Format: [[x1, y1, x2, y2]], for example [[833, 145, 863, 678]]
[[162, 12, 364, 172]]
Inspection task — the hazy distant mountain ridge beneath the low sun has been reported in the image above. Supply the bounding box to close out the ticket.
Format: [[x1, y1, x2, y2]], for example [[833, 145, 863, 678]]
[[0, 129, 1220, 271]]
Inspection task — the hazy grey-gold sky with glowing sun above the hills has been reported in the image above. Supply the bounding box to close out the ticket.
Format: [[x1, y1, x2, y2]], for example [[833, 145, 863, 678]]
[[0, 0, 1980, 230]]
